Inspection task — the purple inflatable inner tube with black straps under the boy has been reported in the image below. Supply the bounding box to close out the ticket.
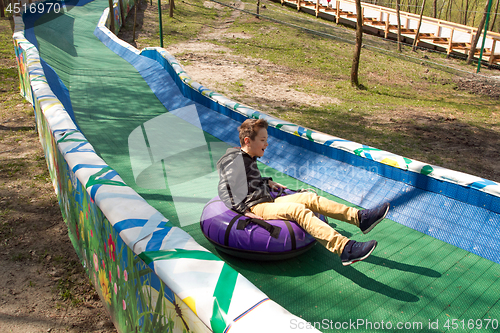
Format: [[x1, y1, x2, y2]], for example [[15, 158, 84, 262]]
[[201, 191, 326, 254]]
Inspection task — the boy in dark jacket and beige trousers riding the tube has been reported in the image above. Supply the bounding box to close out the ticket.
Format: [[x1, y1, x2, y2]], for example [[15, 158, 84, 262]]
[[217, 119, 389, 266]]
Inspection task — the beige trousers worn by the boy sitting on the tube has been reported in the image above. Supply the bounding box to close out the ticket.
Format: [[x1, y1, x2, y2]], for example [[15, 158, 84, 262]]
[[250, 192, 359, 256]]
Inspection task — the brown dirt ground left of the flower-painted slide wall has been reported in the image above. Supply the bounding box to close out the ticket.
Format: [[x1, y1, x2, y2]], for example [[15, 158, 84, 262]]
[[0, 19, 116, 333]]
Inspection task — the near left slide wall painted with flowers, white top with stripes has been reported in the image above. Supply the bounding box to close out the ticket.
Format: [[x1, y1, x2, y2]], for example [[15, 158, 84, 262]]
[[14, 1, 320, 332]]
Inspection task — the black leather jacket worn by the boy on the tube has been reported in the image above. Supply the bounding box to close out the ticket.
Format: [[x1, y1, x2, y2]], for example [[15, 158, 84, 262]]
[[217, 148, 274, 214]]
